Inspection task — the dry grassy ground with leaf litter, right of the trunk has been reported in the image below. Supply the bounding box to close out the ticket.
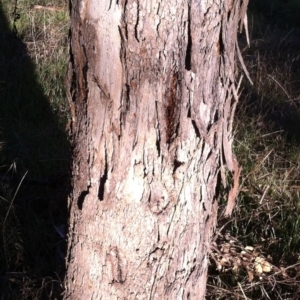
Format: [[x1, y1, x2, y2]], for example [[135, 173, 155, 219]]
[[207, 0, 300, 300]]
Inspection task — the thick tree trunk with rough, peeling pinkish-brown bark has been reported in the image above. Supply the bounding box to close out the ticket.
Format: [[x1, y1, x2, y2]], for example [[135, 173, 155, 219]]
[[64, 0, 248, 300]]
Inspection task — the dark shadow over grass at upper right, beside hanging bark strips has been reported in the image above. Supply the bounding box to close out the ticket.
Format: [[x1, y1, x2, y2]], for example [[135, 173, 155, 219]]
[[237, 0, 300, 145]]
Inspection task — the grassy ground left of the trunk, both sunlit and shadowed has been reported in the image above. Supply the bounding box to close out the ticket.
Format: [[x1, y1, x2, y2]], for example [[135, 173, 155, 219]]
[[0, 0, 70, 299]]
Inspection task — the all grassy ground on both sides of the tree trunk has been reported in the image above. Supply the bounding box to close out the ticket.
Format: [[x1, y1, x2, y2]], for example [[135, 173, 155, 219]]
[[0, 0, 300, 300]]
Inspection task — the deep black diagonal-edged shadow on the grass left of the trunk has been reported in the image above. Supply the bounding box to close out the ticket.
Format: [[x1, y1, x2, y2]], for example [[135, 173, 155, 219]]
[[0, 3, 70, 299]]
